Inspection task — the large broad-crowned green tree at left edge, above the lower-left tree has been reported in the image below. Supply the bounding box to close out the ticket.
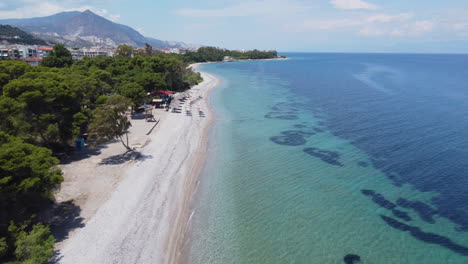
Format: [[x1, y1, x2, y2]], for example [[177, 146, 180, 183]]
[[3, 72, 83, 146]]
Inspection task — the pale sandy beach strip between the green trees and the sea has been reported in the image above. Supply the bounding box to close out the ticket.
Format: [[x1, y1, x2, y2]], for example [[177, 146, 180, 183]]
[[56, 65, 219, 264]]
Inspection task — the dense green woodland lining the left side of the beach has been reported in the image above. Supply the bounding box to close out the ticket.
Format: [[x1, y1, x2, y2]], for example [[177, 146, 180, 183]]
[[0, 45, 201, 263]]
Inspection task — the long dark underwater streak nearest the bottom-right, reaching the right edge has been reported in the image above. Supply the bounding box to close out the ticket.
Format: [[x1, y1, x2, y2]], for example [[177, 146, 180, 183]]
[[380, 215, 468, 256]]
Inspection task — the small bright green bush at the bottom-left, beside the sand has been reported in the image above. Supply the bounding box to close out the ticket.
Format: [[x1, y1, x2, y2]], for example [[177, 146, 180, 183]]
[[15, 224, 55, 264]]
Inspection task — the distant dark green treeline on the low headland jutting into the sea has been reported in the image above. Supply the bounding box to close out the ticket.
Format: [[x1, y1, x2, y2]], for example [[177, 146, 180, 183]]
[[184, 47, 278, 62]]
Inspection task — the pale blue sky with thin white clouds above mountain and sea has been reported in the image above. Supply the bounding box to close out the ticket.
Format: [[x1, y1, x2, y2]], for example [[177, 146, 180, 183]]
[[0, 0, 468, 53]]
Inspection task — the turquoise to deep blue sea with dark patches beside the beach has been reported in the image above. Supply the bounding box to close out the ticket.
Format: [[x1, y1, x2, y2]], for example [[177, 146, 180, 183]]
[[187, 53, 468, 264]]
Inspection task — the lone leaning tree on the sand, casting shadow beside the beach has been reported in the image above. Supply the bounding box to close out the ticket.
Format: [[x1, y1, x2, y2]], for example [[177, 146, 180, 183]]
[[88, 95, 133, 151]]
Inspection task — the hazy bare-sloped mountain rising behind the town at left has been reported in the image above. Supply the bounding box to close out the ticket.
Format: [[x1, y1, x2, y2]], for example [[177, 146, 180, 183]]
[[0, 10, 199, 48]]
